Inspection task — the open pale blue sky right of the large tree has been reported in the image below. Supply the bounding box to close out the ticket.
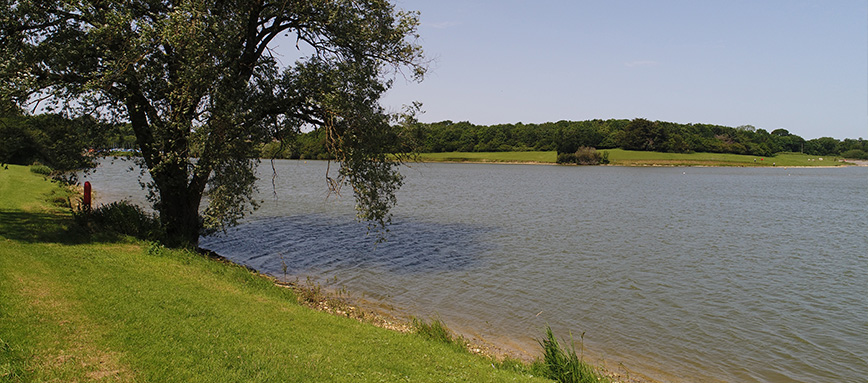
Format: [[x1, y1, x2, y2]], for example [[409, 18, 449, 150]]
[[383, 0, 868, 139]]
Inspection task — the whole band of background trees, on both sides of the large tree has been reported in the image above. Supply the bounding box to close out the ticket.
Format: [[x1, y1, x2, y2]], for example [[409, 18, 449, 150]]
[[0, 108, 868, 170]]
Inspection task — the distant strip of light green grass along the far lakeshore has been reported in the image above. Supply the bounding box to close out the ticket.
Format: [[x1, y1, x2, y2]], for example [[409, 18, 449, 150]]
[[410, 149, 845, 166]]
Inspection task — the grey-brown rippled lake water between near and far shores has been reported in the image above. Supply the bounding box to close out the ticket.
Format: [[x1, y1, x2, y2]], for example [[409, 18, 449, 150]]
[[88, 161, 868, 382]]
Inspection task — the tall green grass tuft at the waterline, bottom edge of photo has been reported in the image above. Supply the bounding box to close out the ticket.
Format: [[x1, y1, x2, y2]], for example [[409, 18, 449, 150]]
[[539, 327, 609, 383]]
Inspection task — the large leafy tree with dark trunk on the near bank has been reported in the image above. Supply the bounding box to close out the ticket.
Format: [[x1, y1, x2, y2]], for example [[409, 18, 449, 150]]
[[0, 0, 425, 245]]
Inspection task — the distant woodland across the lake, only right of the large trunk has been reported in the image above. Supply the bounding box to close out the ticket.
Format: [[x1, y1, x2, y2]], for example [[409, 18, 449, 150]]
[[263, 119, 868, 159]]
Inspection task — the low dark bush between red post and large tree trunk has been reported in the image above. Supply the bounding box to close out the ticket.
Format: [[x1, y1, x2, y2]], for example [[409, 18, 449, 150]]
[[73, 201, 163, 240]]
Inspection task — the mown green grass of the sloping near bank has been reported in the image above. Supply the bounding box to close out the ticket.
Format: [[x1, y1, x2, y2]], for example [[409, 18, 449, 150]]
[[0, 166, 536, 382]]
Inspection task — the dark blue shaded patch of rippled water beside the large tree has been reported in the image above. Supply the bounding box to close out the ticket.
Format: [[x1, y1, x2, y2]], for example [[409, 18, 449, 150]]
[[200, 214, 491, 276]]
